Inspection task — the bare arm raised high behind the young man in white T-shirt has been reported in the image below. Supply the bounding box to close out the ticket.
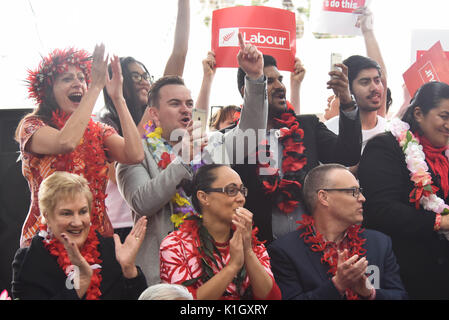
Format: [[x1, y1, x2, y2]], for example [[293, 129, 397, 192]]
[[354, 7, 387, 118]]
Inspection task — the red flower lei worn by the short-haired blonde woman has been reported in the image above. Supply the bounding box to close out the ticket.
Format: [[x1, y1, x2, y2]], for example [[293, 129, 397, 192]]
[[40, 225, 103, 300]]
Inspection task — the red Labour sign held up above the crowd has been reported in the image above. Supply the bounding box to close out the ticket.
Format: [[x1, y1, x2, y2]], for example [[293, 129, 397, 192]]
[[212, 6, 296, 71]]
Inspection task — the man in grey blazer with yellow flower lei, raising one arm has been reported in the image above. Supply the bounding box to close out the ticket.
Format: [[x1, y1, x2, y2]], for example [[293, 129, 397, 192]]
[[117, 36, 268, 285]]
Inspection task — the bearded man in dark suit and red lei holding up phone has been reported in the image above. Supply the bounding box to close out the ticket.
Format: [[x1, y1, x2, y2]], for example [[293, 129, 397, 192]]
[[234, 55, 361, 243]]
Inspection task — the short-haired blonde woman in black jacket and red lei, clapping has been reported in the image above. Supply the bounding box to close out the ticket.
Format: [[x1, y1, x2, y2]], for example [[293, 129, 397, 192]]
[[12, 172, 147, 300]]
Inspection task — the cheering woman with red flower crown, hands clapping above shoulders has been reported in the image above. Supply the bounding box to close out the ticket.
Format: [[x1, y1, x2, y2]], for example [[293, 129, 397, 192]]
[[16, 45, 143, 247]]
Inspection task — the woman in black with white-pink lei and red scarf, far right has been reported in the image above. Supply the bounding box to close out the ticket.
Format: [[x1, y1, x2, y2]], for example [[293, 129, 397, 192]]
[[358, 82, 449, 299]]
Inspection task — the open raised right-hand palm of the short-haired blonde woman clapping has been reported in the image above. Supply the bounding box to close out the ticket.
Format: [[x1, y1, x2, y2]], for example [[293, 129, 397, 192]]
[[114, 216, 147, 279]]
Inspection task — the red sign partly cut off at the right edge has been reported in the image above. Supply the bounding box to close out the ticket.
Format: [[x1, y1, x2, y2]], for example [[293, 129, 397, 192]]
[[403, 41, 449, 97]]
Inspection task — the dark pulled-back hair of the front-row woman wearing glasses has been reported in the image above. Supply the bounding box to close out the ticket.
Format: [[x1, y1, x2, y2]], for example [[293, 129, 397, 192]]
[[181, 164, 225, 213]]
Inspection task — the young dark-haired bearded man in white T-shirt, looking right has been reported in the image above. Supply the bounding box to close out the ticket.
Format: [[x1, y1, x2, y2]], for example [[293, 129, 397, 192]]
[[325, 55, 387, 151]]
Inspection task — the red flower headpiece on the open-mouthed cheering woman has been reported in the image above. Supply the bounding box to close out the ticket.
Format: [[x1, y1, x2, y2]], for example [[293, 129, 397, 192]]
[[26, 48, 92, 104]]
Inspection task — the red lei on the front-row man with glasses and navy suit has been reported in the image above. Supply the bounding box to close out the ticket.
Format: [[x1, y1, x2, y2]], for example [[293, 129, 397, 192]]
[[297, 214, 366, 300]]
